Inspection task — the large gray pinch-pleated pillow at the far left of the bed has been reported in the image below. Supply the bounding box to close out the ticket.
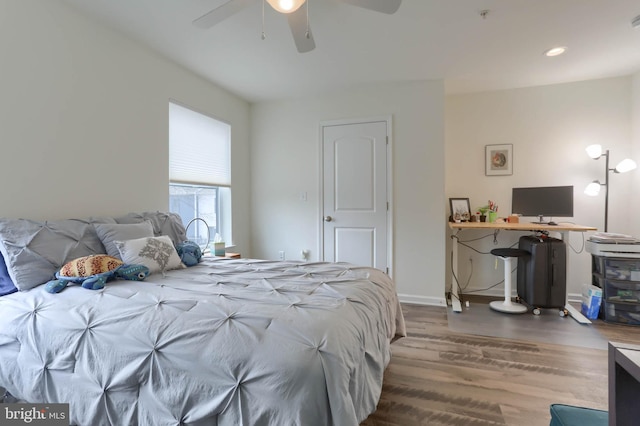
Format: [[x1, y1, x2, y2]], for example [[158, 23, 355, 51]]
[[0, 218, 114, 291]]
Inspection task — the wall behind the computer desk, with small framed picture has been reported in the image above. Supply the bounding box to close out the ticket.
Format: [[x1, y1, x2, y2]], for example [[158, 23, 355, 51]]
[[441, 77, 640, 302]]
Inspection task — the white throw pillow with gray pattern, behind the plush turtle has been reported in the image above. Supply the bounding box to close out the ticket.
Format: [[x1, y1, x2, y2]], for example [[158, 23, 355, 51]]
[[114, 235, 185, 273]]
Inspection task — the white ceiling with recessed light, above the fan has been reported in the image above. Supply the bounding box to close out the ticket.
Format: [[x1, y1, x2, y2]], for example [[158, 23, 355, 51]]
[[63, 0, 640, 102]]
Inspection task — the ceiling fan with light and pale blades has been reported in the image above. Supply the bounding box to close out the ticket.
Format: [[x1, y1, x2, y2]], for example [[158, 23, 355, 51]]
[[193, 0, 402, 53]]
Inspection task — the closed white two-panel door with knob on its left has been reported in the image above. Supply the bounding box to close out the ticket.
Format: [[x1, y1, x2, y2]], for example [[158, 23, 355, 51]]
[[322, 121, 390, 271]]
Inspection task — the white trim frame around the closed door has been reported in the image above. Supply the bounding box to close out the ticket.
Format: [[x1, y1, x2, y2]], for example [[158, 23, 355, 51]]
[[318, 115, 392, 276]]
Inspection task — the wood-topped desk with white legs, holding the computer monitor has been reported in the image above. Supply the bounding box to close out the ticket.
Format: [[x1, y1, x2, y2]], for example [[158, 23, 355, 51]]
[[449, 222, 598, 324]]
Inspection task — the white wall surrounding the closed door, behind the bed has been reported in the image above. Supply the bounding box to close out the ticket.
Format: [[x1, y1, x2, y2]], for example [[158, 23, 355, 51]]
[[251, 81, 445, 303]]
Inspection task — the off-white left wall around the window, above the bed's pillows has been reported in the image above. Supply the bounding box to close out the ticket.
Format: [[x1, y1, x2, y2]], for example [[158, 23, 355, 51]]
[[0, 0, 250, 250]]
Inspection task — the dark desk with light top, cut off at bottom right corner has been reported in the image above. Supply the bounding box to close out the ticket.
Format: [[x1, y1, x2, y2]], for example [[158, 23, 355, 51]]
[[609, 342, 640, 426]]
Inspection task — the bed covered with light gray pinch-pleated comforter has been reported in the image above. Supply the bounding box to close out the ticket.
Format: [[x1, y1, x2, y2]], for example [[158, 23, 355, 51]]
[[0, 215, 406, 426]]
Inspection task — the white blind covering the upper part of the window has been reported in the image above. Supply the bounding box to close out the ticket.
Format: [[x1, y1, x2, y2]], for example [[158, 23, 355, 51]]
[[169, 102, 231, 186]]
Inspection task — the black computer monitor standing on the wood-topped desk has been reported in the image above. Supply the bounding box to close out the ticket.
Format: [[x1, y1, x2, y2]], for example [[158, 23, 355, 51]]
[[511, 185, 573, 223]]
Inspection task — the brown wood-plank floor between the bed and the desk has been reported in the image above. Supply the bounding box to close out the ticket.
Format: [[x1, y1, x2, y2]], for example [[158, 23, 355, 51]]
[[361, 304, 640, 426]]
